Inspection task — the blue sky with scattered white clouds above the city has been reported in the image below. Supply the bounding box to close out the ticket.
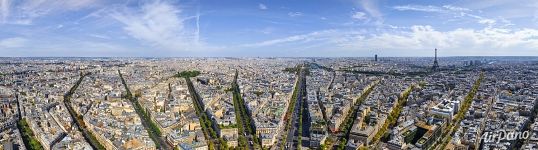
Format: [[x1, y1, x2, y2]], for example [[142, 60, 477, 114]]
[[0, 0, 538, 57]]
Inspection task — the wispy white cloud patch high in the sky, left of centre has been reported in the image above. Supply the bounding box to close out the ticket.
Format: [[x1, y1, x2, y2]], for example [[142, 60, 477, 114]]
[[112, 1, 199, 50]]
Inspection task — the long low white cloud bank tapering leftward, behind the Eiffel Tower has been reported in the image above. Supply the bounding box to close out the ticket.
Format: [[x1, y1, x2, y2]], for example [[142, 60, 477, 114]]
[[246, 25, 538, 56]]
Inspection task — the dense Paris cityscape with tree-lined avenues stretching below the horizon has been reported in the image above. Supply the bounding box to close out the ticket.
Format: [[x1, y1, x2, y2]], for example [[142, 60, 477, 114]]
[[0, 55, 538, 150]]
